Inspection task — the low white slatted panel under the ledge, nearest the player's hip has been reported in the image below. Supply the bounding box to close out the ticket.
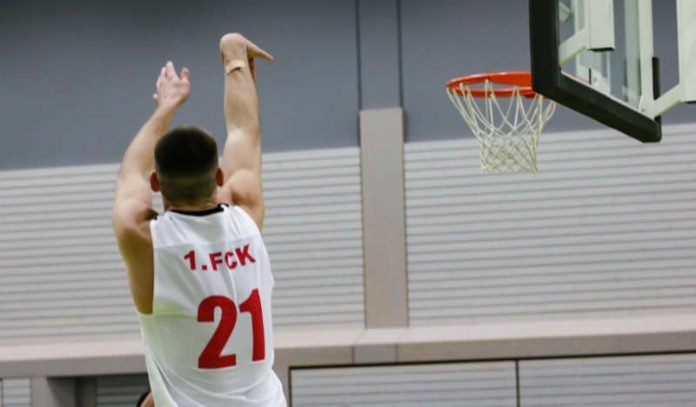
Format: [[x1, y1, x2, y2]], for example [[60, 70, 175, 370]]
[[291, 362, 517, 407]]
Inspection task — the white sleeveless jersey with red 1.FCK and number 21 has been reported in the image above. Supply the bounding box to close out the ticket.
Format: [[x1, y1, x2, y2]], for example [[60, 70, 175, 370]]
[[140, 205, 286, 407]]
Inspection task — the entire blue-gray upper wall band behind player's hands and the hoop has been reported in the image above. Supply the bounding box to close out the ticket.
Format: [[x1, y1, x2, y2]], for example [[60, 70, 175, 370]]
[[0, 0, 694, 169]]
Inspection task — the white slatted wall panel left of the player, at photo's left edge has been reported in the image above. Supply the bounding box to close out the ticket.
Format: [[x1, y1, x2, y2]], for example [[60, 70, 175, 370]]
[[0, 164, 139, 344]]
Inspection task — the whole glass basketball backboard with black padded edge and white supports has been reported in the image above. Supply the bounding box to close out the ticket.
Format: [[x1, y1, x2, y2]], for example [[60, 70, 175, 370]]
[[529, 0, 696, 142]]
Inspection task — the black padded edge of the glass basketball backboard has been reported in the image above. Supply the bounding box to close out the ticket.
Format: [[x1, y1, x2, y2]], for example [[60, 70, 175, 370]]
[[529, 0, 662, 143]]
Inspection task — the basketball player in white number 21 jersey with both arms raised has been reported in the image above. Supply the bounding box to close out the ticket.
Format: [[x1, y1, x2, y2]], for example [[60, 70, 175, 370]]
[[113, 34, 286, 407]]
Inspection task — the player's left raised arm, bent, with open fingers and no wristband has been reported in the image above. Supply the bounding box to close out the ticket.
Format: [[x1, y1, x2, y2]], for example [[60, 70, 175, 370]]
[[113, 62, 191, 266]]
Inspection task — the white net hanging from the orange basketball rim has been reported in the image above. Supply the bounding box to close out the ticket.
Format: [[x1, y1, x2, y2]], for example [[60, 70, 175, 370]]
[[447, 80, 556, 173]]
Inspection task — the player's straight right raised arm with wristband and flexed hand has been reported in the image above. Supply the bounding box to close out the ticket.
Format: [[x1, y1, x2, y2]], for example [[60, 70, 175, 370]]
[[218, 34, 273, 228]]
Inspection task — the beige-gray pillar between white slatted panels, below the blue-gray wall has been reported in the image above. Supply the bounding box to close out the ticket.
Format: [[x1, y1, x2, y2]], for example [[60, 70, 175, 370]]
[[360, 108, 408, 328]]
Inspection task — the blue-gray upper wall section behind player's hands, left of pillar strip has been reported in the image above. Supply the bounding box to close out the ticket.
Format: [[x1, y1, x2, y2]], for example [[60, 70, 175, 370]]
[[0, 0, 358, 169]]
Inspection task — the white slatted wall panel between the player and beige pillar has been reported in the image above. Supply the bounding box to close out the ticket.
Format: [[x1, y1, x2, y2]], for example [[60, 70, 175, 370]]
[[263, 148, 364, 329]]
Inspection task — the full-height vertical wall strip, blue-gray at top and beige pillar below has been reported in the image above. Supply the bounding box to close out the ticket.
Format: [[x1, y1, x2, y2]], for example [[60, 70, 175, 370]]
[[357, 0, 408, 328]]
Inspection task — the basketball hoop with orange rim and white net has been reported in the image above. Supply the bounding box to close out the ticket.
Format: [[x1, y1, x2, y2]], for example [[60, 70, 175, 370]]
[[447, 72, 556, 173]]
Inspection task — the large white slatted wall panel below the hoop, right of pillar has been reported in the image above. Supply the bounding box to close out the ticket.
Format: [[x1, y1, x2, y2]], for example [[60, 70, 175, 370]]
[[405, 126, 696, 325]]
